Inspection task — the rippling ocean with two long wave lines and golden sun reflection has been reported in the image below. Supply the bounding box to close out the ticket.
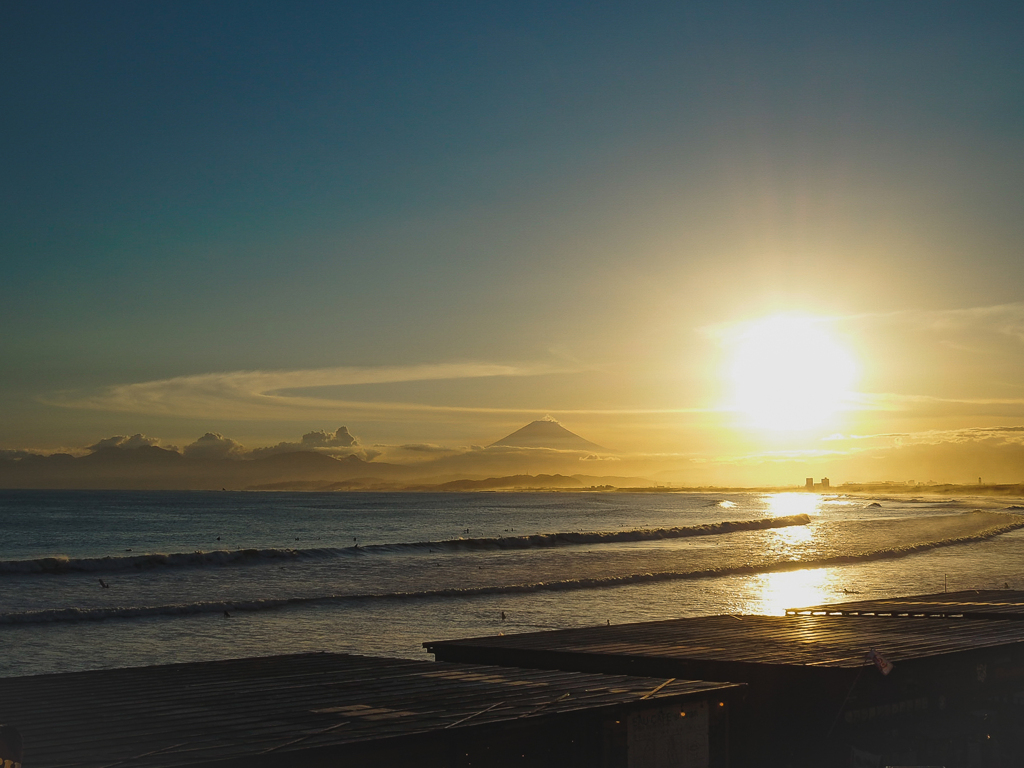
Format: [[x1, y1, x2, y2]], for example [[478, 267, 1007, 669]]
[[0, 490, 1024, 677]]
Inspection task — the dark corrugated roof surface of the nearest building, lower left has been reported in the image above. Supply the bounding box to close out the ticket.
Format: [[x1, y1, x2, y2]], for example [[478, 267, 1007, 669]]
[[0, 653, 737, 768]]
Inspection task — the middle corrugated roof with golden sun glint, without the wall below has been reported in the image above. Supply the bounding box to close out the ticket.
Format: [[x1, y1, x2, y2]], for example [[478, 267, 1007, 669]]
[[424, 615, 1024, 668]]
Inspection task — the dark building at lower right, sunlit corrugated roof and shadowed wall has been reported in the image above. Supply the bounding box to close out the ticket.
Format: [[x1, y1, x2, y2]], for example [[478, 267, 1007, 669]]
[[426, 592, 1024, 768]]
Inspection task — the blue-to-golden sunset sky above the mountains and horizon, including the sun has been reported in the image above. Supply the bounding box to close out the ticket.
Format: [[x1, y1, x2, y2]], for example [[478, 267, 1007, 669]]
[[0, 0, 1024, 484]]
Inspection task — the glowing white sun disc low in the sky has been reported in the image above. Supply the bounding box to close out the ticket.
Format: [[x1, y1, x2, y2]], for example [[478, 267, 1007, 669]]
[[729, 315, 857, 431]]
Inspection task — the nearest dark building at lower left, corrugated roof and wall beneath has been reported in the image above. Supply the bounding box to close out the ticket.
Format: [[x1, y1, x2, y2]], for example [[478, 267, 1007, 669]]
[[0, 653, 743, 768]]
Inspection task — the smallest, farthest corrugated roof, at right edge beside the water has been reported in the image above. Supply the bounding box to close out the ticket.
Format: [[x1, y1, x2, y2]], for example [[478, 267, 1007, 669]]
[[785, 590, 1024, 621]]
